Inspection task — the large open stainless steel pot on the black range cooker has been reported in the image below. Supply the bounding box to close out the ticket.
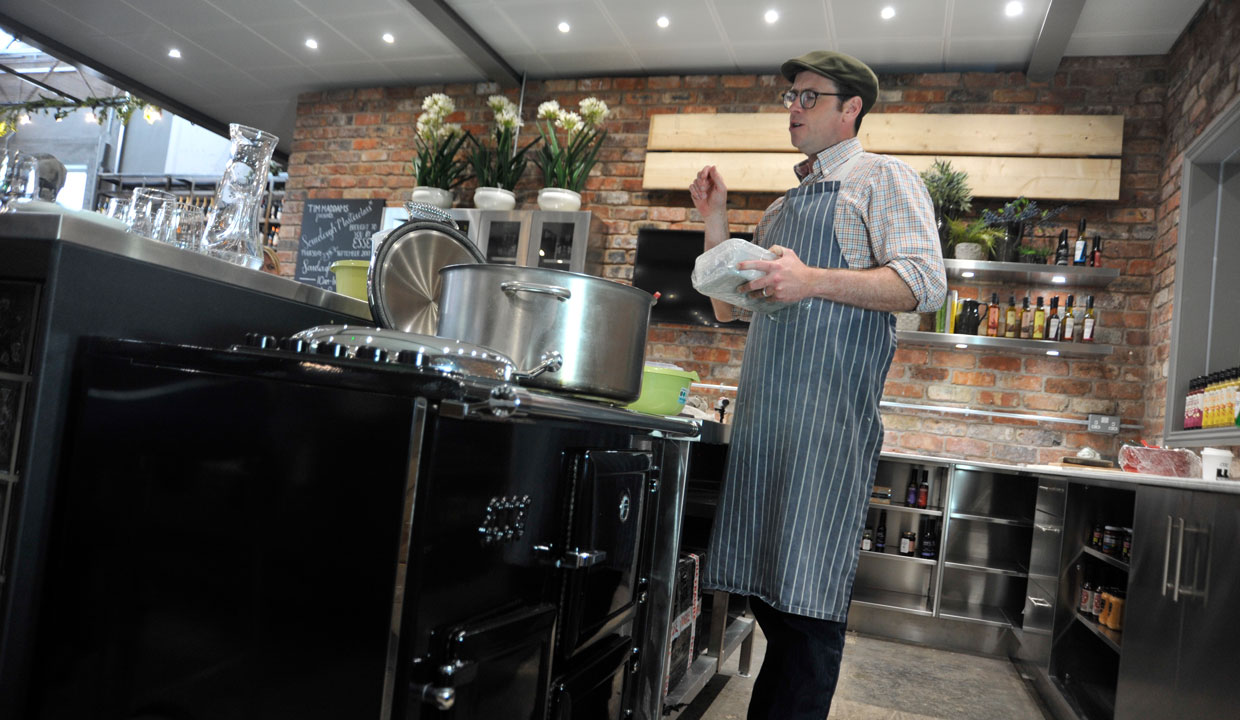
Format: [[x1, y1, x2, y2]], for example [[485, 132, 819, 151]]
[[435, 264, 655, 403]]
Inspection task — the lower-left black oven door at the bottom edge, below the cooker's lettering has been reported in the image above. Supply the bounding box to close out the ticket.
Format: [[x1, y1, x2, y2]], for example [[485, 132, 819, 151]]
[[403, 604, 556, 720]]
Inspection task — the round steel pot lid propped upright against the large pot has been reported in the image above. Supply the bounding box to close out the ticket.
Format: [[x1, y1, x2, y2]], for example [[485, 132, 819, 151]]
[[366, 214, 486, 337]]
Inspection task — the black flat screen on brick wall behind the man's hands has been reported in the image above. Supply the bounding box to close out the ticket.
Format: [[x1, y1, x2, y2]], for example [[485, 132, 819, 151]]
[[632, 228, 753, 327]]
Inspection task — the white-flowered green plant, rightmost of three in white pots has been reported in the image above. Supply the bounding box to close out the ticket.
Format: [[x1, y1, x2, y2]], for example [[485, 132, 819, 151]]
[[534, 98, 610, 192]]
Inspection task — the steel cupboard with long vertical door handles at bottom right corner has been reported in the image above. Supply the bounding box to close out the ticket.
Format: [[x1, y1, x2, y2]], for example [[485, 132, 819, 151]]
[[1115, 487, 1240, 720]]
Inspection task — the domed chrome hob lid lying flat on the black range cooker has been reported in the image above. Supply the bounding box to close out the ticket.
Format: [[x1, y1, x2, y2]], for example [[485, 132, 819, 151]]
[[293, 325, 516, 382]]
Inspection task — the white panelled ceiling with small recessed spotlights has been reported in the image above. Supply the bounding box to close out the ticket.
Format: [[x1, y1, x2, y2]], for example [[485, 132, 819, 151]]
[[0, 0, 1203, 149]]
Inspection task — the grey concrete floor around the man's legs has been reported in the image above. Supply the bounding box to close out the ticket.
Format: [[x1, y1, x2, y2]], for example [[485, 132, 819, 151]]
[[670, 619, 1050, 720]]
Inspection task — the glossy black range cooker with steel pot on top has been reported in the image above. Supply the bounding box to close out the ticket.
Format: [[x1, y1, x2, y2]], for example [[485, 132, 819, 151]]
[[22, 336, 696, 720]]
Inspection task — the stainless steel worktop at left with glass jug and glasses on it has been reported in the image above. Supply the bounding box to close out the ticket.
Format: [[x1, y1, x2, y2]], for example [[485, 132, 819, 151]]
[[0, 212, 371, 317]]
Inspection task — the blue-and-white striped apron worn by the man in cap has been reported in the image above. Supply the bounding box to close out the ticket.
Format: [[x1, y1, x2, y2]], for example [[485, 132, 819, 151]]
[[704, 154, 895, 622]]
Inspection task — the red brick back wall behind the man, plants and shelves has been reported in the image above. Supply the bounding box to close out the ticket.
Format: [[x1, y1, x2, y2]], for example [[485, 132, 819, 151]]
[[281, 56, 1169, 461]]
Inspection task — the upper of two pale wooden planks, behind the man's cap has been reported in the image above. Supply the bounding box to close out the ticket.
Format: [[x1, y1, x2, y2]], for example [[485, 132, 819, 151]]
[[646, 113, 1123, 157]]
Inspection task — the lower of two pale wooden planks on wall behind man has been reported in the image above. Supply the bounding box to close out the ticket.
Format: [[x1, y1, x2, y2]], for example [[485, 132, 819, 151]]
[[642, 152, 1120, 200]]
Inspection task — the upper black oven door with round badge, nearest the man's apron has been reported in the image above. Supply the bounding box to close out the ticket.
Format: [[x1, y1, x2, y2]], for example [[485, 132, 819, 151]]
[[548, 450, 653, 657]]
